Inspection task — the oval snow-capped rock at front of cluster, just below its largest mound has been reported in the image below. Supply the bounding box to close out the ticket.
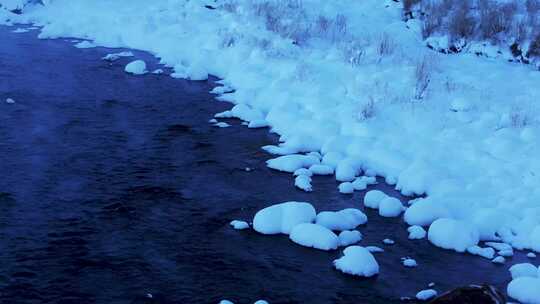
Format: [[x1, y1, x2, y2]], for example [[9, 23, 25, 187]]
[[289, 223, 339, 250]]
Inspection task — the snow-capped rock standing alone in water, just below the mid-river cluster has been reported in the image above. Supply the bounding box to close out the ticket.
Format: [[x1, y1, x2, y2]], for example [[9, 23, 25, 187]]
[[334, 246, 379, 277]]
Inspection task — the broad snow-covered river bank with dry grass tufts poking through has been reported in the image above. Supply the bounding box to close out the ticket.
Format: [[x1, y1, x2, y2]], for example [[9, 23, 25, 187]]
[[3, 1, 540, 302]]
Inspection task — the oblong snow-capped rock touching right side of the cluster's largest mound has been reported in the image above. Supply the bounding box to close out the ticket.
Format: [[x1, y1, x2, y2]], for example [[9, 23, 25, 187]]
[[316, 208, 367, 231]]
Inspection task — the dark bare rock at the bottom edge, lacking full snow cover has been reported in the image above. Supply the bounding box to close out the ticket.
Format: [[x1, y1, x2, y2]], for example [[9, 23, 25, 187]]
[[429, 284, 506, 304]]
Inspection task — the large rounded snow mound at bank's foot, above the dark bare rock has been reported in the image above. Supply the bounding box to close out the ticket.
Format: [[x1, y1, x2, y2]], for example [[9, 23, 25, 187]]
[[428, 218, 479, 252]]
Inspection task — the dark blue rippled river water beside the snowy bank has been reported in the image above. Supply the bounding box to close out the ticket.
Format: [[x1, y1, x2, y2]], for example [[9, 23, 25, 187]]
[[0, 26, 525, 304]]
